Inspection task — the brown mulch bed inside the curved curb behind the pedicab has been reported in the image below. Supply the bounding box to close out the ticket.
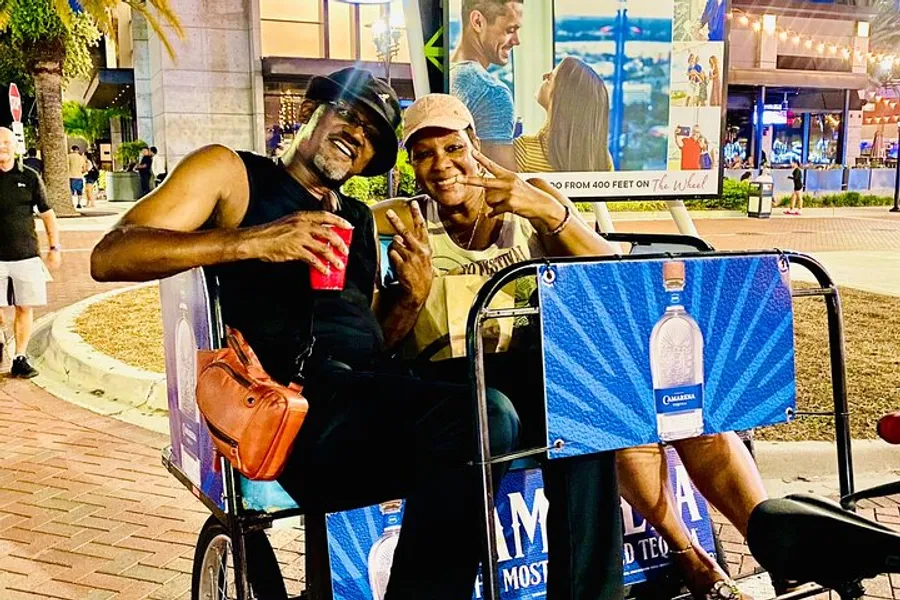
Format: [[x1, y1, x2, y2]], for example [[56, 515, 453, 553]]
[[76, 283, 900, 441]]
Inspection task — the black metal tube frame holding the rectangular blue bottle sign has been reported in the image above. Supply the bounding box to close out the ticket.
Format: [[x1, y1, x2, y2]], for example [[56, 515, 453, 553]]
[[466, 248, 854, 600]]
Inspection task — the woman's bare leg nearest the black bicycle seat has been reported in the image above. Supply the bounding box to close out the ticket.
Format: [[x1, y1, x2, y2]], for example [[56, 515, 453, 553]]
[[672, 432, 768, 537]]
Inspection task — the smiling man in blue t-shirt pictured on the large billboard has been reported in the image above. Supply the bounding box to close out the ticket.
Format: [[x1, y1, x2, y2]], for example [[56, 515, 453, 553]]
[[450, 0, 522, 170]]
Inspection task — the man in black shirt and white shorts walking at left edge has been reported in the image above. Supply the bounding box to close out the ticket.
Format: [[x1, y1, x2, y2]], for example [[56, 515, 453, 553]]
[[0, 127, 60, 378]]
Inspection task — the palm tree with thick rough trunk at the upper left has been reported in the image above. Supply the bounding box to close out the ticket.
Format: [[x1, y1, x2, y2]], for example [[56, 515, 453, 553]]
[[0, 0, 184, 215]]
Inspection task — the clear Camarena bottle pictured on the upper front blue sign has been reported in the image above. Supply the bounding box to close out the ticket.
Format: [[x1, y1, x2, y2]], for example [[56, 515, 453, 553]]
[[650, 261, 703, 442]]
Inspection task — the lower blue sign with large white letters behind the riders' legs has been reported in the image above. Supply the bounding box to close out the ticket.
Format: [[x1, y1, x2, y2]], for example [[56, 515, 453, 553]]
[[326, 448, 716, 600]]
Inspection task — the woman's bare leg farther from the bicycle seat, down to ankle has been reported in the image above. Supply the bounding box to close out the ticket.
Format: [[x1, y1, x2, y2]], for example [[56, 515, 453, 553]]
[[616, 444, 726, 597]]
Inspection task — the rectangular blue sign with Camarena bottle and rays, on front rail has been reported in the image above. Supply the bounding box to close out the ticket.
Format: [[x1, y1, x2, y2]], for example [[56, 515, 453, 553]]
[[538, 255, 796, 458]]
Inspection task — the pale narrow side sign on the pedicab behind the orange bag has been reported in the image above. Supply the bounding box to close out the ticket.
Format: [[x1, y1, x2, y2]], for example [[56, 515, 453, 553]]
[[159, 269, 225, 510]]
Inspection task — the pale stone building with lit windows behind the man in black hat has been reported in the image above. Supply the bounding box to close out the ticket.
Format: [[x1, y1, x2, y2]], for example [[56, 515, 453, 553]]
[[84, 0, 413, 169]]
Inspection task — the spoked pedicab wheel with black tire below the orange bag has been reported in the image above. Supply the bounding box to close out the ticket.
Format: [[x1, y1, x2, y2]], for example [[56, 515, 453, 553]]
[[191, 515, 287, 600]]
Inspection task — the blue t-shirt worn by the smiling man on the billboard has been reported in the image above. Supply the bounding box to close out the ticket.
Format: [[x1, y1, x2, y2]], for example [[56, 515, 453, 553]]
[[450, 60, 516, 144]]
